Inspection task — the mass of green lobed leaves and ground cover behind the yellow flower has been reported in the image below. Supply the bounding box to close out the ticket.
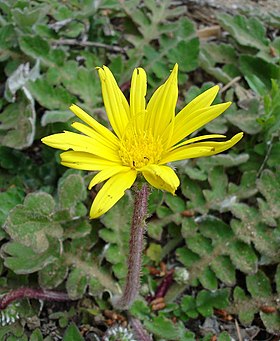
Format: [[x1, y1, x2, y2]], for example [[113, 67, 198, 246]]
[[0, 0, 280, 341]]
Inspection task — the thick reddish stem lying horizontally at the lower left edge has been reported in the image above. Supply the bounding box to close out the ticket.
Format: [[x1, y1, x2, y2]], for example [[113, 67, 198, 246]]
[[0, 288, 70, 310]]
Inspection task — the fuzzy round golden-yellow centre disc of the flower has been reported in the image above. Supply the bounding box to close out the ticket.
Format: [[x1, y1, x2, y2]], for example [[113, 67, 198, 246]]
[[119, 131, 163, 169]]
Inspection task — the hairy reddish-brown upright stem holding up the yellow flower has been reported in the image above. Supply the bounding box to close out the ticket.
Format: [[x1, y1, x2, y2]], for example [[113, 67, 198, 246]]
[[116, 184, 149, 309]]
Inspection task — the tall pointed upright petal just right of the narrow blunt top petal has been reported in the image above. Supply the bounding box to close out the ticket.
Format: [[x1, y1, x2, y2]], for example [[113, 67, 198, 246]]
[[146, 64, 178, 136]]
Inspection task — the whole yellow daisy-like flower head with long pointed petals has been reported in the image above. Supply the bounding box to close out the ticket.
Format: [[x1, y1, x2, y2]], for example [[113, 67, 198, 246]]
[[42, 64, 243, 218]]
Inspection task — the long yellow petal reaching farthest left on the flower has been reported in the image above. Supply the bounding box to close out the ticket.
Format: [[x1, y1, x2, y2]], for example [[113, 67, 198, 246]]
[[41, 131, 120, 163]]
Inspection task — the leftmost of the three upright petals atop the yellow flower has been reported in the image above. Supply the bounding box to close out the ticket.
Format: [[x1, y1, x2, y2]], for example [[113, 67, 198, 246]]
[[97, 66, 130, 138]]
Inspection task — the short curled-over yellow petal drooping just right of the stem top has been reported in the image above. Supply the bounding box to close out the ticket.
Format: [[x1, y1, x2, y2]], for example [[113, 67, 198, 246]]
[[141, 165, 180, 194]]
